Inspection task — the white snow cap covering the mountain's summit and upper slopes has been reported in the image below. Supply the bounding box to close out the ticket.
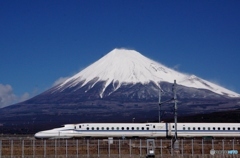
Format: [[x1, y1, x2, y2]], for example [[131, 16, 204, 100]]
[[57, 49, 240, 97]]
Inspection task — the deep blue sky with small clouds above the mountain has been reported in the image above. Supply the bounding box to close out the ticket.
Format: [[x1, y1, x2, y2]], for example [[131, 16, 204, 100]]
[[0, 0, 240, 107]]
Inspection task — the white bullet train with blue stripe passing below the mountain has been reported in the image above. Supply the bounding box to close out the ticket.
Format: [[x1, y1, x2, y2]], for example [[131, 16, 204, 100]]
[[34, 123, 240, 139]]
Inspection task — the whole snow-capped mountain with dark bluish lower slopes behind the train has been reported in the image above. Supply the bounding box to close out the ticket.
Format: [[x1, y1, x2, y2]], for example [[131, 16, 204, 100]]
[[0, 49, 240, 133]]
